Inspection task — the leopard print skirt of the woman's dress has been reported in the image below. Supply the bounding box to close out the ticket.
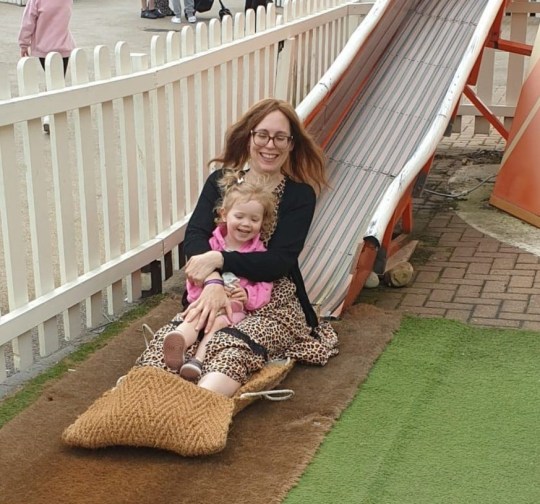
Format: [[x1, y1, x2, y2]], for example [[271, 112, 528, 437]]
[[136, 278, 338, 385]]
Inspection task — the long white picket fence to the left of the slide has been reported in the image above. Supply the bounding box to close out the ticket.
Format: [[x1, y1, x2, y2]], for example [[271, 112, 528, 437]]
[[0, 0, 371, 382]]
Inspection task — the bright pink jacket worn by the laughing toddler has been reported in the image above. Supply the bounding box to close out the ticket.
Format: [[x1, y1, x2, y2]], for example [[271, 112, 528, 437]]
[[186, 226, 272, 311]]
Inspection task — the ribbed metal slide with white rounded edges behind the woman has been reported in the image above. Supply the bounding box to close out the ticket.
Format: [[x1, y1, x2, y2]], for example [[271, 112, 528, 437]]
[[297, 0, 504, 316]]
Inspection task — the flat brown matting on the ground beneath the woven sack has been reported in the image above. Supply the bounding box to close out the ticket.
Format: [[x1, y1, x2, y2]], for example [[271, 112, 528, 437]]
[[0, 299, 400, 504]]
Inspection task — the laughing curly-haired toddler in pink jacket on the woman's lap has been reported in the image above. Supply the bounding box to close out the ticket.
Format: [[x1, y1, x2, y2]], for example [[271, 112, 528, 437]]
[[163, 180, 275, 381]]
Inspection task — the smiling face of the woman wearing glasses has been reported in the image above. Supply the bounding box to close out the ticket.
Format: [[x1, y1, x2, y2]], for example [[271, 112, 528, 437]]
[[249, 110, 294, 177]]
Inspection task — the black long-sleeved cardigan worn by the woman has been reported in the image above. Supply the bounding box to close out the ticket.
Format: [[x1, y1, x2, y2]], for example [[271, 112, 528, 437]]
[[184, 170, 318, 327]]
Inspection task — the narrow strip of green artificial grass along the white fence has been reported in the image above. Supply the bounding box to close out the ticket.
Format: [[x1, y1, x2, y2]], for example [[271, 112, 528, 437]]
[[0, 295, 165, 429]]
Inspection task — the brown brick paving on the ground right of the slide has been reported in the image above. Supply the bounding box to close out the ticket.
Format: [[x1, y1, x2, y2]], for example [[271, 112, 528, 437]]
[[358, 123, 540, 331]]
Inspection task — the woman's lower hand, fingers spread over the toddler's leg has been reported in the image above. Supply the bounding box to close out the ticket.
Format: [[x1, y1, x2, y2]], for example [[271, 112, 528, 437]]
[[181, 284, 232, 334]]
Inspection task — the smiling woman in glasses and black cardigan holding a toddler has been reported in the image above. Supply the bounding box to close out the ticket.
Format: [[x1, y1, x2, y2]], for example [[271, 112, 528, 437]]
[[137, 98, 337, 396]]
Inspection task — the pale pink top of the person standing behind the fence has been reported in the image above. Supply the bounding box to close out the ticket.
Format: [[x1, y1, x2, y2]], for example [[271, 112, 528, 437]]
[[19, 0, 75, 58]]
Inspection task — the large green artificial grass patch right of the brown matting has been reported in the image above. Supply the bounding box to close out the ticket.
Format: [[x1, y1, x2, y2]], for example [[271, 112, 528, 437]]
[[284, 317, 540, 504]]
